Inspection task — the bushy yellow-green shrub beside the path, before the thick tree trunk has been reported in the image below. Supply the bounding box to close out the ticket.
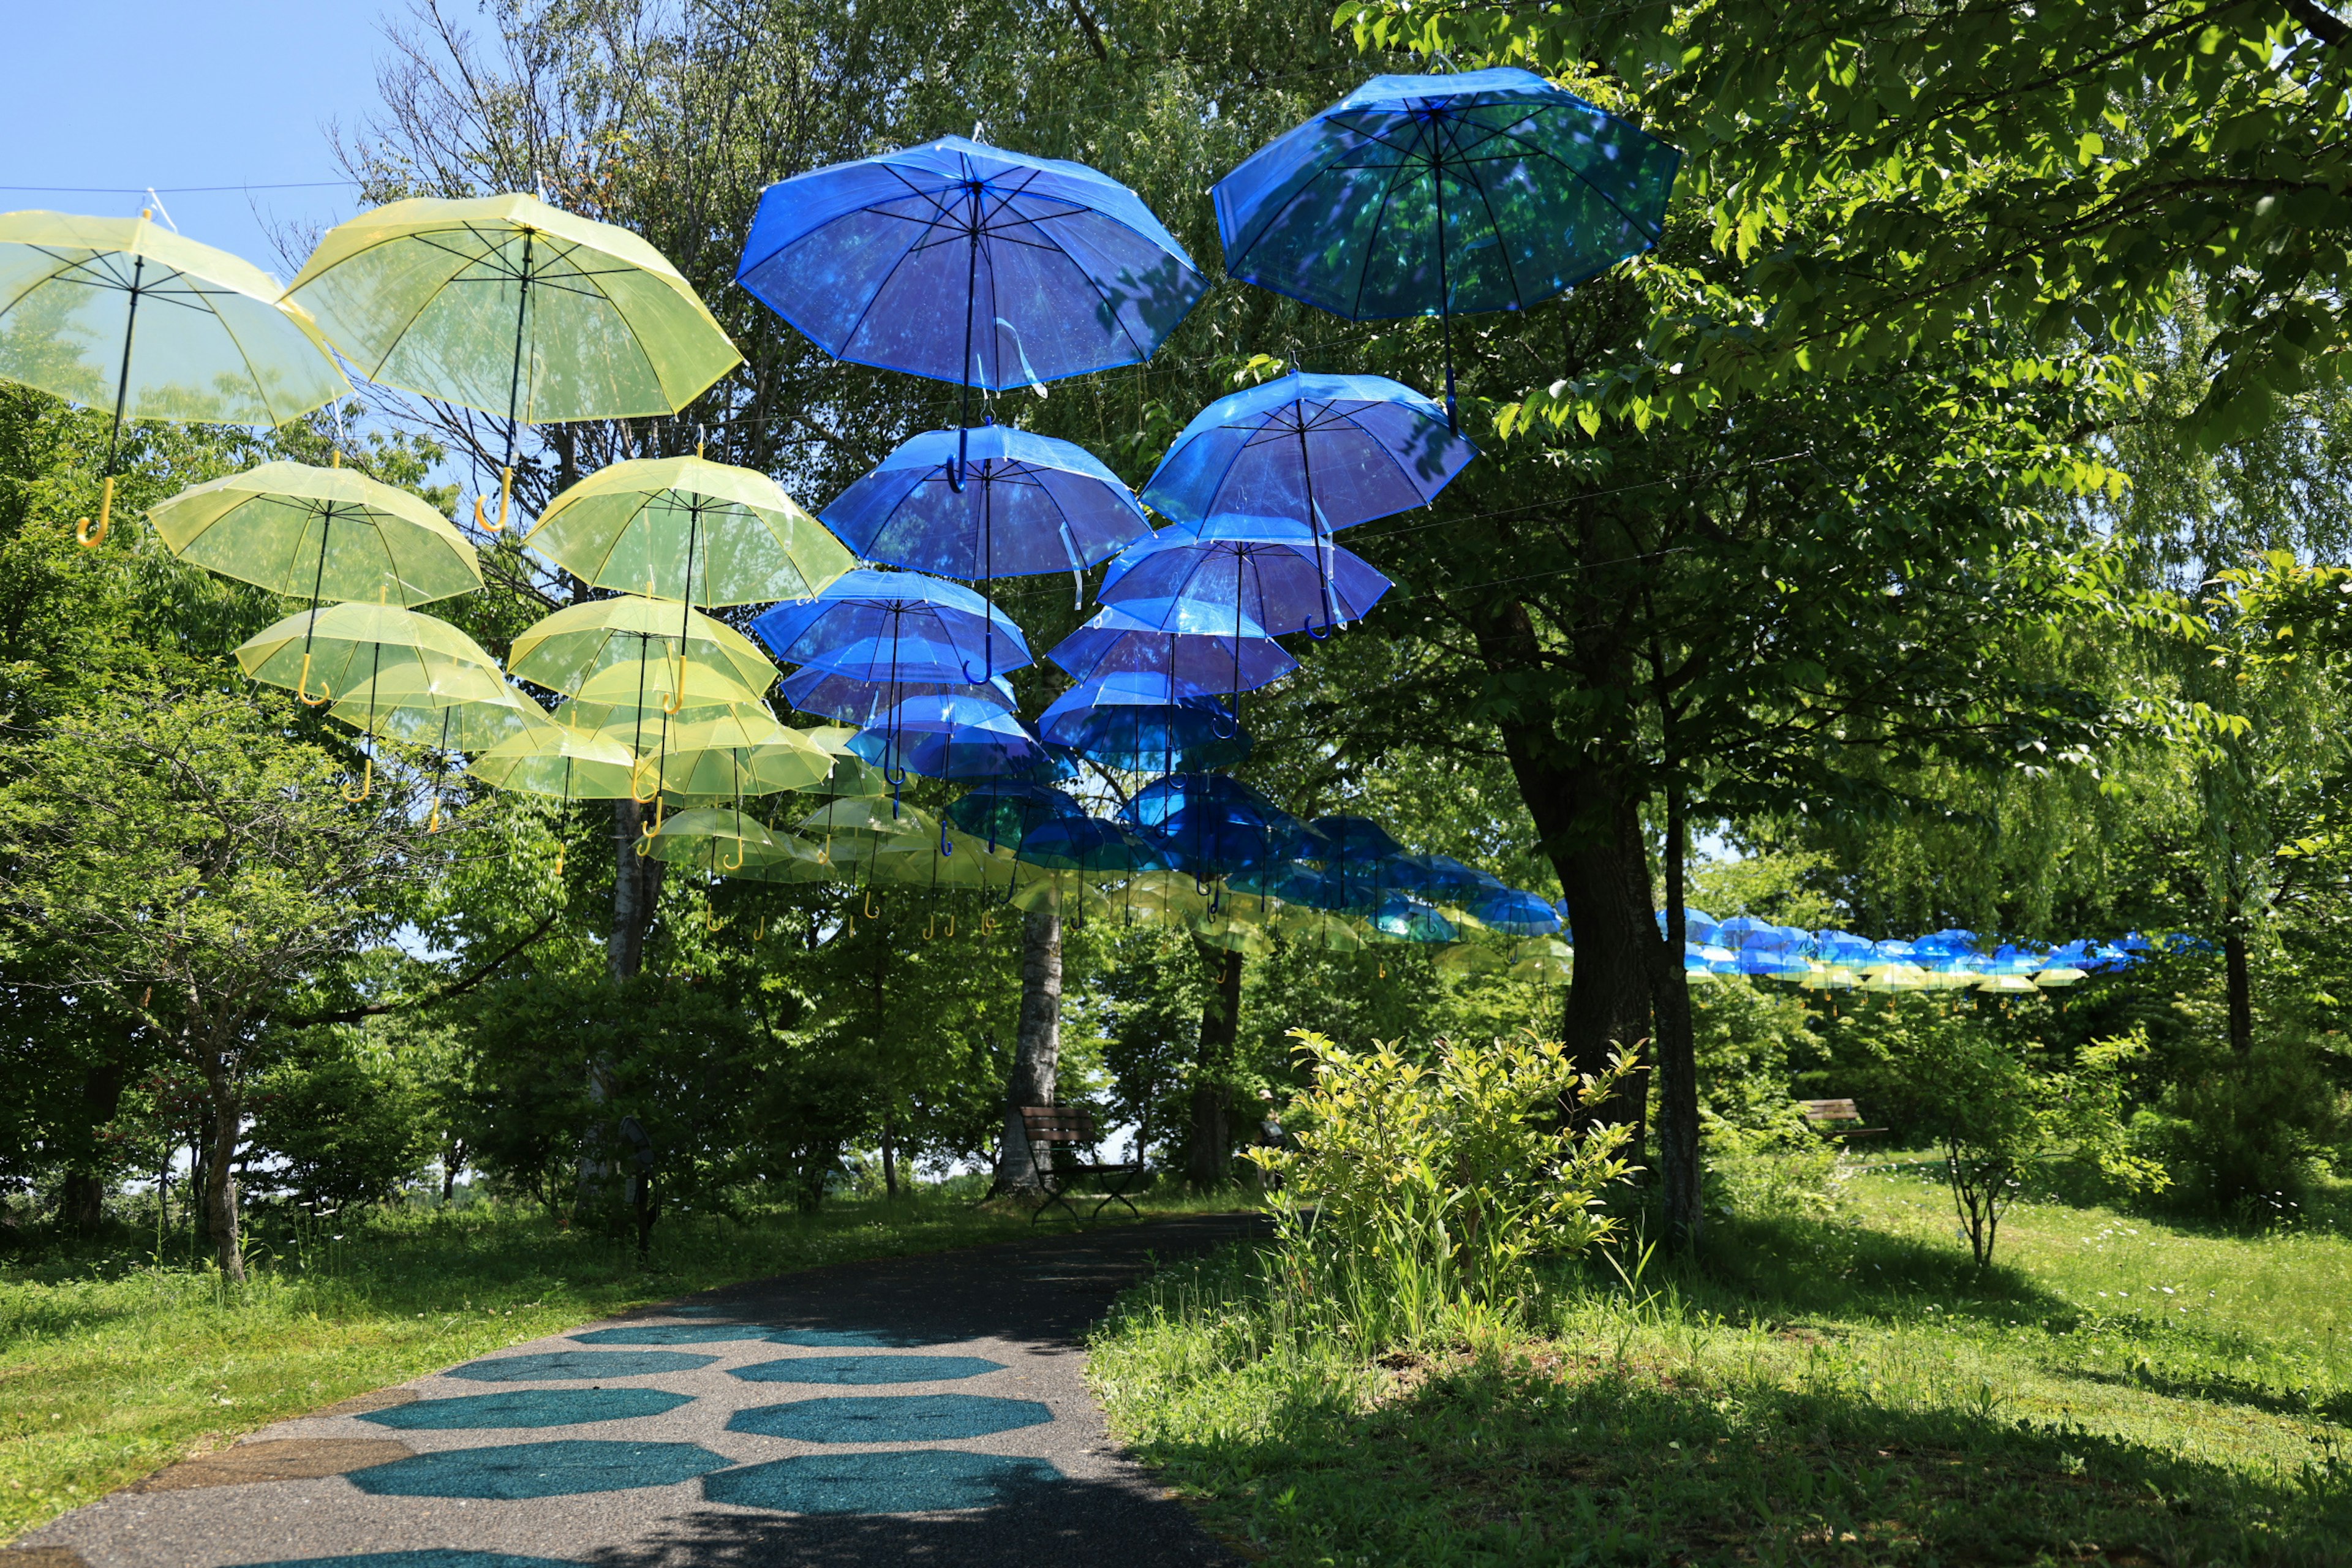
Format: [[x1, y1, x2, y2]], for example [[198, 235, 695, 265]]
[[1246, 1030, 1627, 1344]]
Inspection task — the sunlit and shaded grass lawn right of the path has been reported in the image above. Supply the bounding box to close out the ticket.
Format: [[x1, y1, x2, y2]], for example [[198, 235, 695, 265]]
[[1091, 1164, 2352, 1568]]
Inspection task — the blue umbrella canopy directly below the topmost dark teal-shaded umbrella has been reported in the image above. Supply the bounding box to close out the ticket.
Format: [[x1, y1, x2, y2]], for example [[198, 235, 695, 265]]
[[1143, 374, 1477, 531]]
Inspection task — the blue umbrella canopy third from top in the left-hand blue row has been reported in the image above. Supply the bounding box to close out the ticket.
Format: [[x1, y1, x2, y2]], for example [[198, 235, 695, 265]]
[[750, 567, 1030, 684]]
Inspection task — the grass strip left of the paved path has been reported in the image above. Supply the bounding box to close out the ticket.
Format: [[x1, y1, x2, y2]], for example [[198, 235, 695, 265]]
[[0, 1194, 1213, 1542]]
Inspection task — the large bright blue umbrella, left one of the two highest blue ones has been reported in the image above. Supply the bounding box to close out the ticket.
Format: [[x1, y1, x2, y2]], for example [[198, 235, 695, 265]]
[[736, 137, 1209, 482]]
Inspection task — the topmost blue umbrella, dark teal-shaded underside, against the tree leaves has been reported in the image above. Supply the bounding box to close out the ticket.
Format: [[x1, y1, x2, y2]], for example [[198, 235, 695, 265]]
[[1216, 66, 1682, 423]]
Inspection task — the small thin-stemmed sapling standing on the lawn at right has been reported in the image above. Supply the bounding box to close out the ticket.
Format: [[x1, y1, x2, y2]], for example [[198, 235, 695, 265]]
[[1870, 999, 2168, 1267]]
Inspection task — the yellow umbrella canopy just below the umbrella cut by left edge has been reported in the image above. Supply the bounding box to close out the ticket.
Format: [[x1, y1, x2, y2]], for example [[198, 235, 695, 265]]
[[148, 463, 482, 606]]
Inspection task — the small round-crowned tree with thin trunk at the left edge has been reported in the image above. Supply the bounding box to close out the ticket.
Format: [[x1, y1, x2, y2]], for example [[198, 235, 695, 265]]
[[0, 679, 449, 1281]]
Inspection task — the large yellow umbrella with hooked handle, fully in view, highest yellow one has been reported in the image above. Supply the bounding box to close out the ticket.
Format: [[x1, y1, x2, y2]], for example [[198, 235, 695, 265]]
[[287, 193, 743, 531]]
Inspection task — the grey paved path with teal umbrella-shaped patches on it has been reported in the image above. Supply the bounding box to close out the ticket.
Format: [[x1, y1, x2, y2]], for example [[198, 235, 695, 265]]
[[0, 1215, 1251, 1568]]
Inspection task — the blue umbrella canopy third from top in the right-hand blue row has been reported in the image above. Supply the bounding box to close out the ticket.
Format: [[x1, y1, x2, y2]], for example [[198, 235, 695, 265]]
[[1101, 515, 1390, 632]]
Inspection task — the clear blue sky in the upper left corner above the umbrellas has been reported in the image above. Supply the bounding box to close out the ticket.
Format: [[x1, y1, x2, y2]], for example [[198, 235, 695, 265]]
[[0, 0, 418, 275]]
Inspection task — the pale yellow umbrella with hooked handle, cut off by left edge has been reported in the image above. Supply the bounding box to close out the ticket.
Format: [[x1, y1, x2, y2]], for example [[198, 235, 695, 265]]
[[0, 211, 350, 545]]
